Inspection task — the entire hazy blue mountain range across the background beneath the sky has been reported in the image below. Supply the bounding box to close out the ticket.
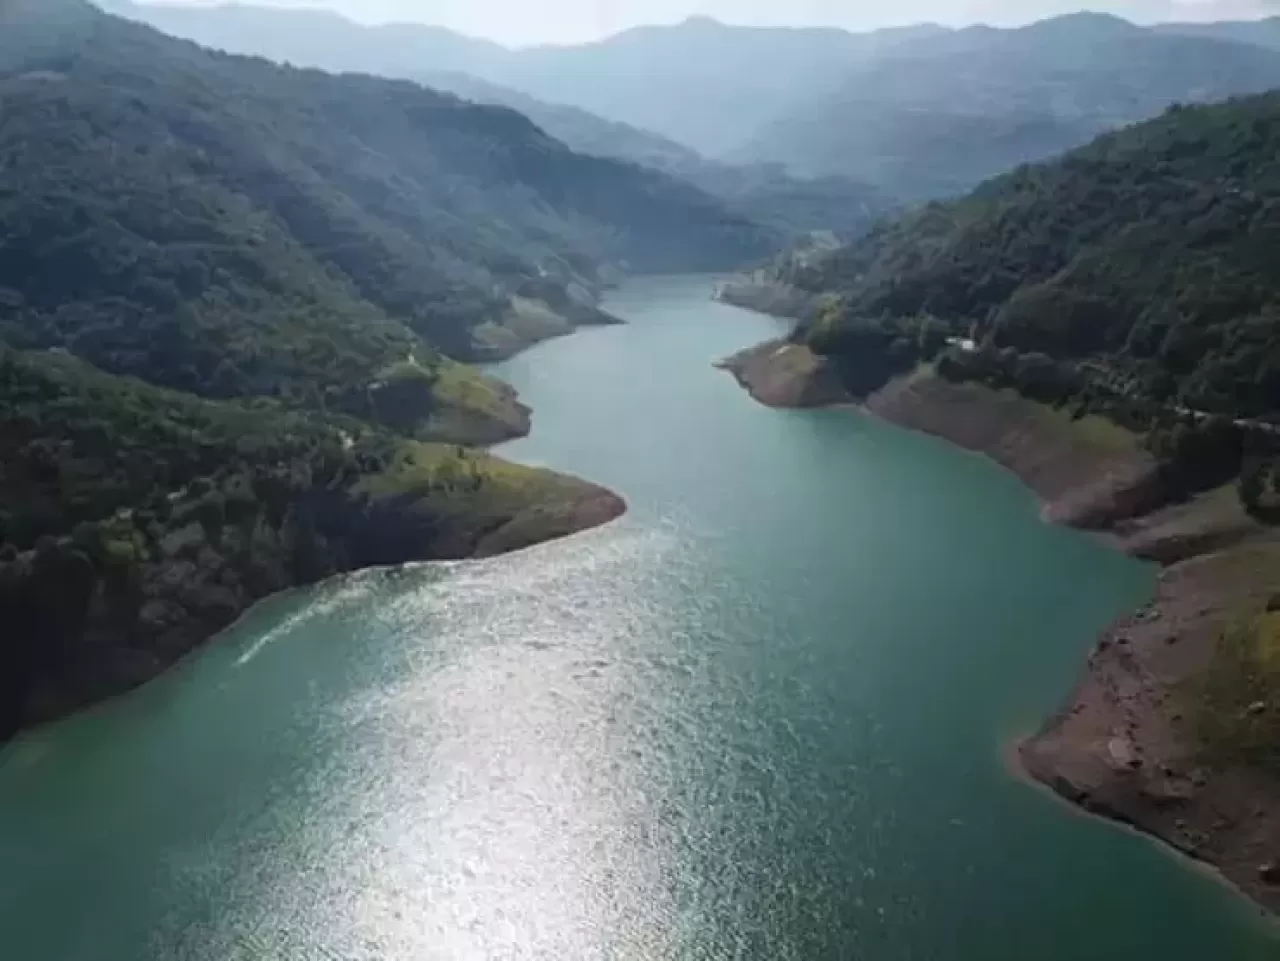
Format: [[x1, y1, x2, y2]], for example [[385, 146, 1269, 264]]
[[102, 0, 1280, 203]]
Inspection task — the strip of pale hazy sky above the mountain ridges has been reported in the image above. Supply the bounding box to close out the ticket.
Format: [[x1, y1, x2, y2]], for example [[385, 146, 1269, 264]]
[[147, 0, 1280, 45]]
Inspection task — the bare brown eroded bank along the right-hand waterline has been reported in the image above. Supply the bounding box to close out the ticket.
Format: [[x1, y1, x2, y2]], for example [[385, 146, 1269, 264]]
[[722, 343, 1280, 911]]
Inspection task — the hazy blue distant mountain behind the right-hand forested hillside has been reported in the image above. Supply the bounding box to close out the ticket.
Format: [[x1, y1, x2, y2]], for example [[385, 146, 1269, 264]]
[[732, 14, 1280, 198]]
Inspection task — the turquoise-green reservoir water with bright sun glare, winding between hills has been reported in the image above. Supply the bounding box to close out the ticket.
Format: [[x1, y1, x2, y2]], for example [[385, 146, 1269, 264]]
[[0, 273, 1277, 961]]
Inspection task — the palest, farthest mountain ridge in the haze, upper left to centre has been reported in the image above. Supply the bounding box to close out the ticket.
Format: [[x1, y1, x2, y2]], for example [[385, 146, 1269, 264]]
[[104, 0, 946, 156]]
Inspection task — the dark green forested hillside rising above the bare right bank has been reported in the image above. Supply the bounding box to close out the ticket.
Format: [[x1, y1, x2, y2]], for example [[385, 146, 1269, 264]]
[[782, 93, 1280, 432]]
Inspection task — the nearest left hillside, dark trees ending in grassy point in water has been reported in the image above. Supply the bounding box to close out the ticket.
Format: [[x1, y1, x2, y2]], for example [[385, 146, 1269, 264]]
[[0, 345, 622, 737]]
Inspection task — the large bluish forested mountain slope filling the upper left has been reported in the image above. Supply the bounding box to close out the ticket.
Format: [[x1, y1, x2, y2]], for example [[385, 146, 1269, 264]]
[[0, 0, 774, 413]]
